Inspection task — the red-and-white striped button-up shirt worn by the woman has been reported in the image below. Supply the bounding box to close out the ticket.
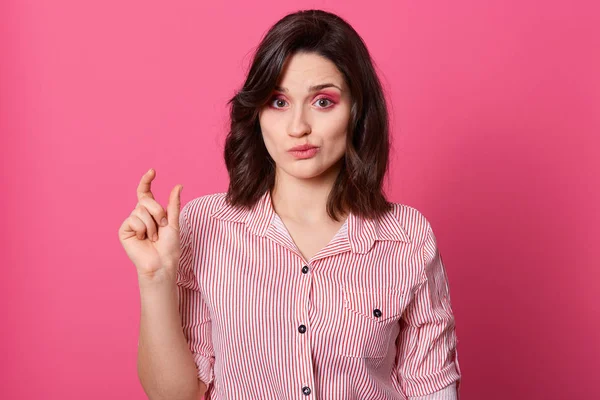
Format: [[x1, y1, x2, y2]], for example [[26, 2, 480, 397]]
[[177, 191, 461, 400]]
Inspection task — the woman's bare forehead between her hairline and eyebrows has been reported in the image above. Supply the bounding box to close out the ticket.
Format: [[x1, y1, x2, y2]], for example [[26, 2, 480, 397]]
[[278, 53, 345, 92]]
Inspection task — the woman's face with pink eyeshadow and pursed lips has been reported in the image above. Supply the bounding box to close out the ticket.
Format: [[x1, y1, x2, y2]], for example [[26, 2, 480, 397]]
[[259, 53, 352, 183]]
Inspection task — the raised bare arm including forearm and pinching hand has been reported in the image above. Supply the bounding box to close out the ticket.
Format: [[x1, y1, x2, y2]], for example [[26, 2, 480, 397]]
[[119, 169, 210, 400]]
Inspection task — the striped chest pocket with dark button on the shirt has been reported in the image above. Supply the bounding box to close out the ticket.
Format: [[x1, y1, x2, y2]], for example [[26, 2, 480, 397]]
[[338, 288, 408, 358]]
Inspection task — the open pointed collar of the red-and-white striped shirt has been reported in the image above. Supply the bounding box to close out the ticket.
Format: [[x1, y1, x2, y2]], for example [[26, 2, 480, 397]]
[[211, 190, 411, 254]]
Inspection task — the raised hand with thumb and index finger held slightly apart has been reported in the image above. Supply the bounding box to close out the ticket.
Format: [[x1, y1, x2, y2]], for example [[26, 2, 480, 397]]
[[119, 169, 183, 282]]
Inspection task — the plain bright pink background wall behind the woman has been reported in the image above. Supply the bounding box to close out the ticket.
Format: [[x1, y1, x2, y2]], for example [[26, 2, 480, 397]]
[[0, 0, 600, 400]]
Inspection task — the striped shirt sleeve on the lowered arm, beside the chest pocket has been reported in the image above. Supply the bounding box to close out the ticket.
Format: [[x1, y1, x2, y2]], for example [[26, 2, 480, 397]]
[[396, 222, 461, 400]]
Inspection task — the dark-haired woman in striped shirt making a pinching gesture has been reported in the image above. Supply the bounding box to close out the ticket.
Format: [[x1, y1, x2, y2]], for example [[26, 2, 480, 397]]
[[120, 10, 461, 399]]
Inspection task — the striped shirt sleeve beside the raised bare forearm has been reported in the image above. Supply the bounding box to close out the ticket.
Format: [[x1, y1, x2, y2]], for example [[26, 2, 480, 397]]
[[177, 202, 215, 387]]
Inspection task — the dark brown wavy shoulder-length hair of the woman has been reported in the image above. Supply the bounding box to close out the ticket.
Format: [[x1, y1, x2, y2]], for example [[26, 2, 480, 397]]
[[224, 10, 392, 221]]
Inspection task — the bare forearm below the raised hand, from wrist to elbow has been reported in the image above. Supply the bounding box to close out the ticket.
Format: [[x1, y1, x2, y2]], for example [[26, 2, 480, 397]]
[[137, 281, 207, 400]]
